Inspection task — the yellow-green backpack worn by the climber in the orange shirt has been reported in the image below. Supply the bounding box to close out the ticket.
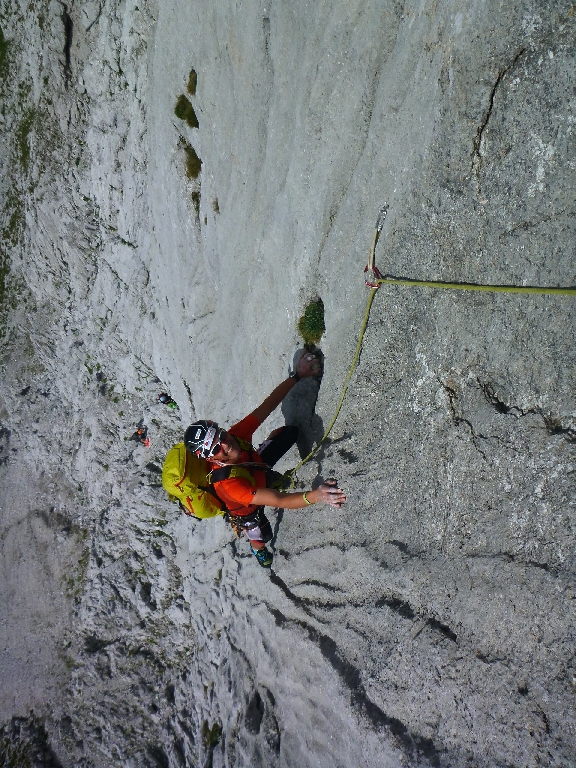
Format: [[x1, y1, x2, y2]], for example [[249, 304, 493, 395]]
[[162, 443, 225, 517]]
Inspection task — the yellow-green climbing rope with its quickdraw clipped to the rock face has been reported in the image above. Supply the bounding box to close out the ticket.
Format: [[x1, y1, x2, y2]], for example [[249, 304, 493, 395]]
[[284, 203, 576, 489]]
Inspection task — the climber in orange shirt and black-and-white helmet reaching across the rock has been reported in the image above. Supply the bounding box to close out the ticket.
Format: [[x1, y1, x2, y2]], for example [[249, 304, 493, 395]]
[[184, 352, 346, 568]]
